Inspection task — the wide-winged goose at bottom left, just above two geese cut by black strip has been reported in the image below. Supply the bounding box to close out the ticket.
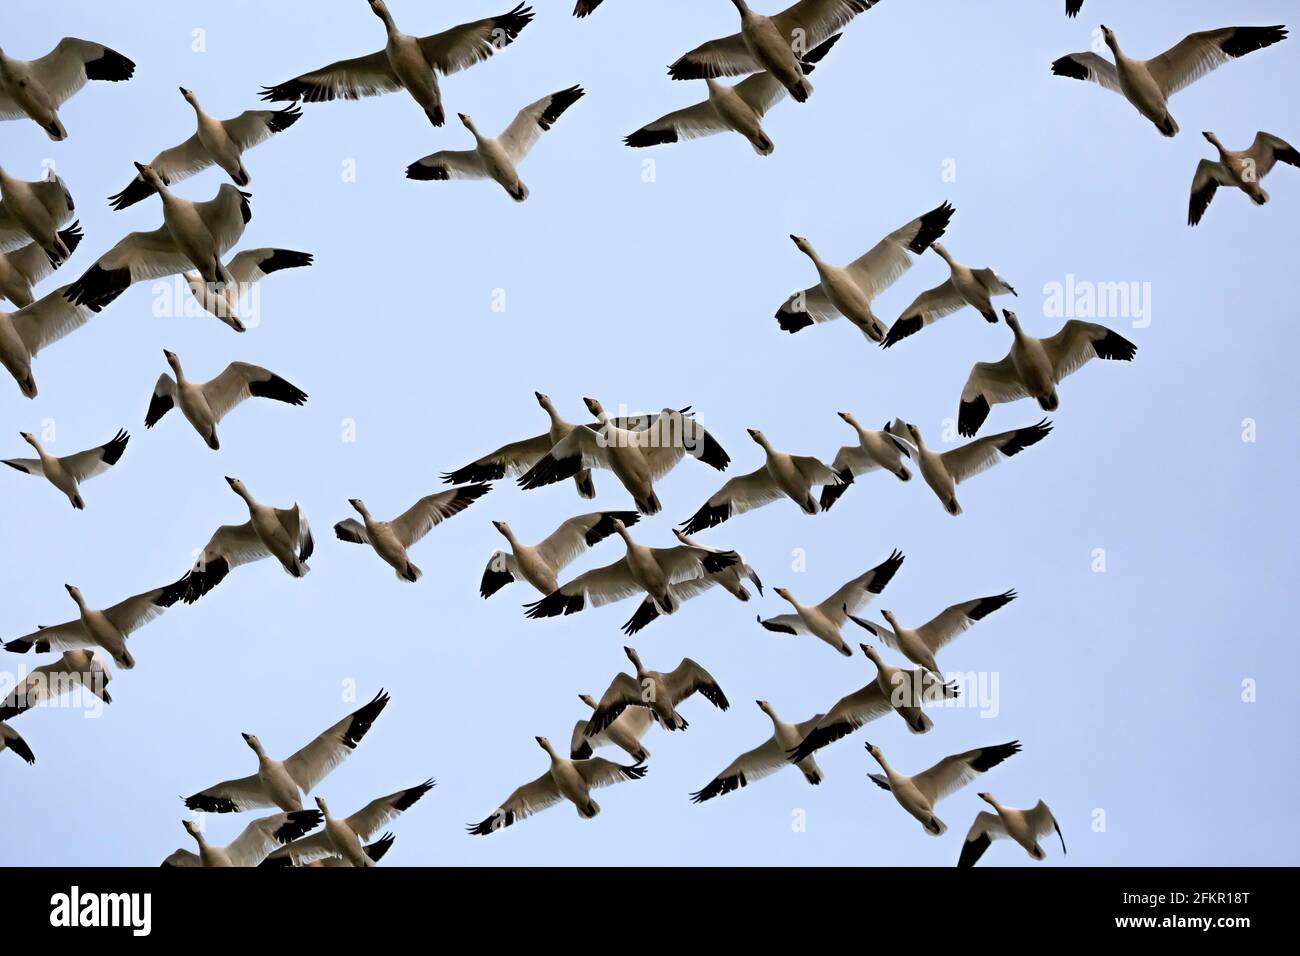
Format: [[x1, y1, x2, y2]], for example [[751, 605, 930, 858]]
[[185, 691, 389, 813]]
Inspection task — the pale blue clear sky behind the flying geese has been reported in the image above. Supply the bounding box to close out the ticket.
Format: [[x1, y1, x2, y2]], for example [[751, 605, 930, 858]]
[[0, 0, 1300, 865]]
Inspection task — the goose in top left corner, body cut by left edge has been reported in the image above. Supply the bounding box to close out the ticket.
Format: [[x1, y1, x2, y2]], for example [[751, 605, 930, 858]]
[[0, 36, 135, 142]]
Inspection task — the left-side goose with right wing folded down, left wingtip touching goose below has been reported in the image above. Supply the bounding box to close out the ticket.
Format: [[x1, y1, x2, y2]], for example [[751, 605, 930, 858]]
[[167, 477, 316, 604]]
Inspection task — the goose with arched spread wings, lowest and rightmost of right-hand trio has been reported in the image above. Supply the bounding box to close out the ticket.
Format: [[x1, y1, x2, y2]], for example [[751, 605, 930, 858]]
[[957, 308, 1138, 437]]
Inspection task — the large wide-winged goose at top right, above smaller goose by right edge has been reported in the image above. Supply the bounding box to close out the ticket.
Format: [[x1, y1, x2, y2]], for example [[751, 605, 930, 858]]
[[1052, 23, 1287, 137]]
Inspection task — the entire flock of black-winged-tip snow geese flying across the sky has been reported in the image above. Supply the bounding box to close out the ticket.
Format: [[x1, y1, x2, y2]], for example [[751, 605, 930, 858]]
[[0, 0, 1300, 866]]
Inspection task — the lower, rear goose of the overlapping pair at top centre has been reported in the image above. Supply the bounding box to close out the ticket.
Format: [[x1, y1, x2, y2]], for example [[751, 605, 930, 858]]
[[623, 34, 840, 156]]
